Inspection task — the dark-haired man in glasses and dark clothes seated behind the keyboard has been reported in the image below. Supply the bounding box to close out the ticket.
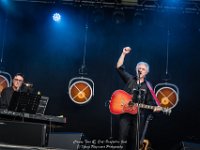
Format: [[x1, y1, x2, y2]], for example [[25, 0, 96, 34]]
[[0, 73, 24, 109]]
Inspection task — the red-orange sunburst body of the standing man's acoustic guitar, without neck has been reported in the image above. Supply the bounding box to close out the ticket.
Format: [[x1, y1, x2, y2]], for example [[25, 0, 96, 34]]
[[109, 90, 137, 115]]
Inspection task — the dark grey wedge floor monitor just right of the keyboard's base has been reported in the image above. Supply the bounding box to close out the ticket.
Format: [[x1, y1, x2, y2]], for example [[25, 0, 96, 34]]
[[48, 132, 83, 150]]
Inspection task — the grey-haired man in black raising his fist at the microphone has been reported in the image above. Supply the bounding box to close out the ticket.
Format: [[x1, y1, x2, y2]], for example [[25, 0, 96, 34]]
[[116, 47, 160, 150]]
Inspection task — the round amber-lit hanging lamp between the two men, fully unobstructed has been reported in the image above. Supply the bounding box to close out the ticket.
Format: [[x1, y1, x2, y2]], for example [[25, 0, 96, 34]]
[[68, 77, 94, 104]]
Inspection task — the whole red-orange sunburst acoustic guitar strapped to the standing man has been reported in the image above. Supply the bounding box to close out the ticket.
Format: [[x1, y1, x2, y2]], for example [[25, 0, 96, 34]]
[[109, 90, 171, 115]]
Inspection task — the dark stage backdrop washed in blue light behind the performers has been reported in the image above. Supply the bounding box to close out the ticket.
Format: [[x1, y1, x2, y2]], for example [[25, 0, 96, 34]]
[[0, 2, 200, 150]]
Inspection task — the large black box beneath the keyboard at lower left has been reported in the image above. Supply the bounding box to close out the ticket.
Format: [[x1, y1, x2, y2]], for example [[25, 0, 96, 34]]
[[0, 121, 47, 146]]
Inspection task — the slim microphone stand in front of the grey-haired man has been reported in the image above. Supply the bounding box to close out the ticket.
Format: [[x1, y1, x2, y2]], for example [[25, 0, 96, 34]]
[[136, 71, 141, 150]]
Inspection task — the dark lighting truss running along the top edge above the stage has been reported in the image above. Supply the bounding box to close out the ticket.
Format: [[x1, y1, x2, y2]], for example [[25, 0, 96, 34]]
[[9, 0, 200, 12]]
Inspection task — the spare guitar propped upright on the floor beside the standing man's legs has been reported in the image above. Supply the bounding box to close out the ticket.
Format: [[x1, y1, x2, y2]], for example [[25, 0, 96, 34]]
[[140, 114, 153, 150]]
